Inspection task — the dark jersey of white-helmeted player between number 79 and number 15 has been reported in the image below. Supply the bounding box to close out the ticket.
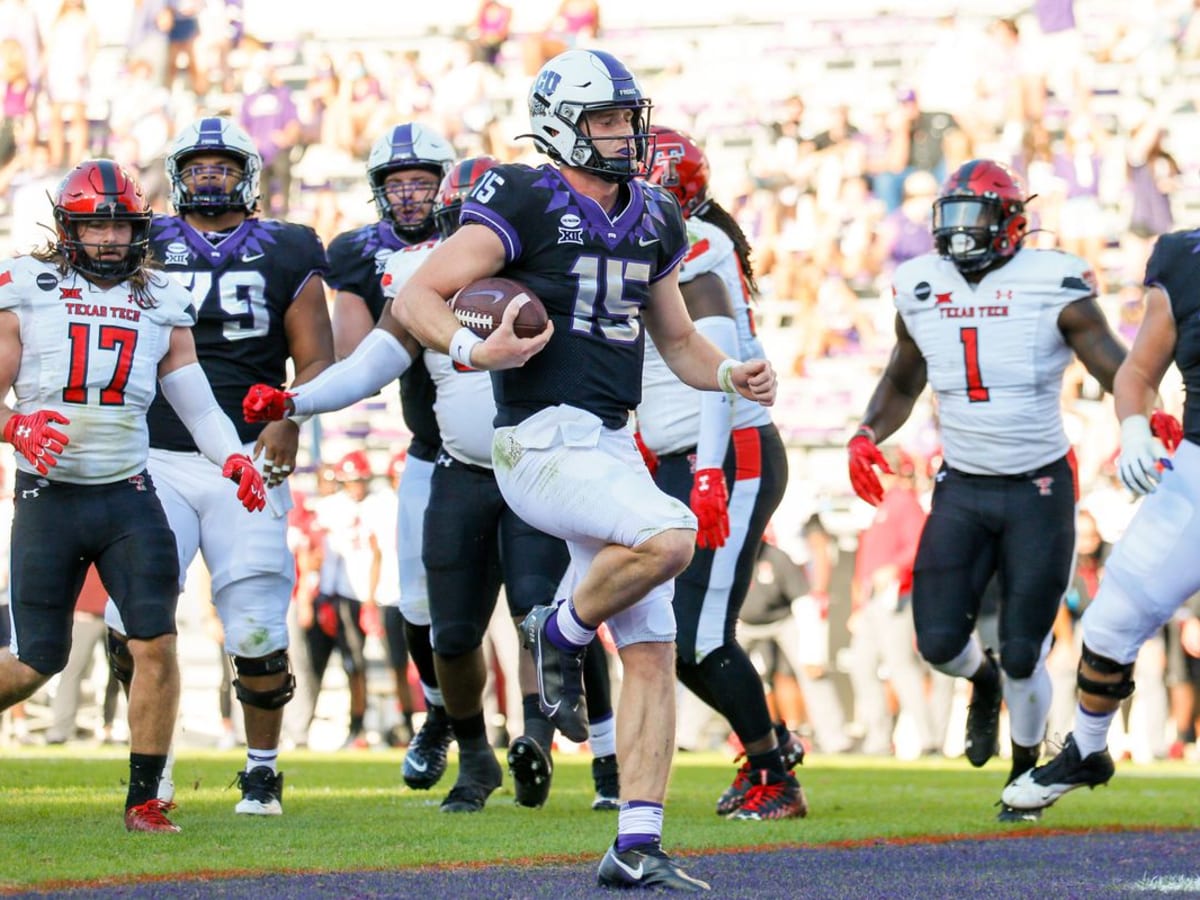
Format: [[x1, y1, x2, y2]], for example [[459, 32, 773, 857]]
[[326, 221, 442, 462]]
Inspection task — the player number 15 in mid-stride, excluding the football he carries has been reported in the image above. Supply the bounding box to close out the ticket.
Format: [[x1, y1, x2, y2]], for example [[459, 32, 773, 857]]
[[392, 50, 775, 890]]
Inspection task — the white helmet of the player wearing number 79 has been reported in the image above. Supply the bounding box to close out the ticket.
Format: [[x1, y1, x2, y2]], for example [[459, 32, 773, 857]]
[[167, 115, 263, 215]]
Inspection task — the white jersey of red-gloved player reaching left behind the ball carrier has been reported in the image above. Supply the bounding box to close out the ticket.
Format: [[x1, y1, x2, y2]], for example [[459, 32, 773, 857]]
[[383, 240, 496, 469]]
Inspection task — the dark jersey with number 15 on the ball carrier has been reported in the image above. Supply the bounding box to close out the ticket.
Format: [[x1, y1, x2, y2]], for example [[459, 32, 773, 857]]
[[462, 164, 688, 428]]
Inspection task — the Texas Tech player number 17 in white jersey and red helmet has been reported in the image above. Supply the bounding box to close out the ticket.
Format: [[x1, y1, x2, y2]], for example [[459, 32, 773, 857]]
[[0, 160, 265, 833]]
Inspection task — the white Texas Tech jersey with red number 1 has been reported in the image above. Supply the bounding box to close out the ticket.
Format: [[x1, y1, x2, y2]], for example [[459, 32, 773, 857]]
[[893, 250, 1096, 475]]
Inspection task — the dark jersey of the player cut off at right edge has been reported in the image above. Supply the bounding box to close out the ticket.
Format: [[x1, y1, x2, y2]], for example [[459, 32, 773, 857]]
[[1146, 230, 1200, 444]]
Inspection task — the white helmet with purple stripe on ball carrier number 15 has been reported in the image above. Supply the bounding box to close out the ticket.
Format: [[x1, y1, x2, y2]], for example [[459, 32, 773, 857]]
[[526, 50, 654, 181]]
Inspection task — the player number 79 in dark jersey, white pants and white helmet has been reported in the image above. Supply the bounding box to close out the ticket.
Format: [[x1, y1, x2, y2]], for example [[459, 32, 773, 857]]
[[106, 116, 334, 816]]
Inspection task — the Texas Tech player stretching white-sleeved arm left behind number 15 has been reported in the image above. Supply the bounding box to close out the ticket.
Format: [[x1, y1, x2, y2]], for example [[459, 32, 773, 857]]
[[244, 157, 617, 812]]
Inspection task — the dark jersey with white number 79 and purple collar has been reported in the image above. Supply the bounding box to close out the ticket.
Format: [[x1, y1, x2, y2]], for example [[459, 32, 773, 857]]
[[146, 216, 329, 451]]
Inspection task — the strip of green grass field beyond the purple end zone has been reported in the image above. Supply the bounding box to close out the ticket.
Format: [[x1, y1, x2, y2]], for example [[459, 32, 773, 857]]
[[0, 749, 1200, 893]]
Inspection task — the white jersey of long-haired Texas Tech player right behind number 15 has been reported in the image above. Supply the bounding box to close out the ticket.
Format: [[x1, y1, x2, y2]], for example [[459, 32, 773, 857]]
[[637, 217, 770, 454]]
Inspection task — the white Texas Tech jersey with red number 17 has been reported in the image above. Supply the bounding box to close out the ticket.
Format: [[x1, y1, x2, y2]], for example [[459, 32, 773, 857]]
[[0, 257, 196, 484]]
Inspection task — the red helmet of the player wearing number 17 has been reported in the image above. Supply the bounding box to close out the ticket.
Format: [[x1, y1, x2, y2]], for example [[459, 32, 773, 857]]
[[54, 160, 150, 281]]
